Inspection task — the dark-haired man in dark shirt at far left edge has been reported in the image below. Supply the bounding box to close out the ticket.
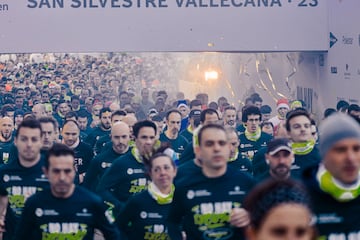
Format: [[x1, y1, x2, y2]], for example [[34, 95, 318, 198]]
[[0, 119, 49, 217]]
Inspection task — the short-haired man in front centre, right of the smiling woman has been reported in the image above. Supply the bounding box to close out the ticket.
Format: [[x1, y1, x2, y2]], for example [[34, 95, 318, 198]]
[[168, 124, 254, 240]]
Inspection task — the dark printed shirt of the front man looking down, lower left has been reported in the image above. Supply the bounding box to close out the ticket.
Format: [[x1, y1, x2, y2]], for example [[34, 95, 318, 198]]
[[15, 186, 120, 240]]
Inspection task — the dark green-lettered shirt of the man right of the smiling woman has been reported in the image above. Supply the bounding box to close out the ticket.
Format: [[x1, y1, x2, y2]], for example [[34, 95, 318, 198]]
[[167, 168, 255, 240]]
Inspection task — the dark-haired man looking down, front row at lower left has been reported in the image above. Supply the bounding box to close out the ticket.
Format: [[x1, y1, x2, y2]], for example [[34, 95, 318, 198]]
[[15, 144, 120, 240]]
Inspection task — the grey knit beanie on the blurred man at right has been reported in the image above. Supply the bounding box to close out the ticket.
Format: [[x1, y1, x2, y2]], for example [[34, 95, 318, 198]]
[[319, 113, 360, 158]]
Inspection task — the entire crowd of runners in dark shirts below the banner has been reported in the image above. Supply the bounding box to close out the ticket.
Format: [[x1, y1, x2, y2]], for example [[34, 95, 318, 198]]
[[0, 54, 360, 240]]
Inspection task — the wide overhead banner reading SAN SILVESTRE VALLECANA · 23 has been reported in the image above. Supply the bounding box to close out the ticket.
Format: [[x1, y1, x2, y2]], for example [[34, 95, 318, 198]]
[[0, 0, 329, 53]]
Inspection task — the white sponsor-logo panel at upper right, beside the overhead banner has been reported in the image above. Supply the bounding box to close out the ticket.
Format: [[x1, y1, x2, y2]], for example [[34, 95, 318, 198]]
[[319, 0, 360, 107]]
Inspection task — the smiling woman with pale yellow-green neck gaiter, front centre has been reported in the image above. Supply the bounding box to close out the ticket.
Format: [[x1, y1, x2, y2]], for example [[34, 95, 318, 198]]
[[118, 153, 176, 239]]
